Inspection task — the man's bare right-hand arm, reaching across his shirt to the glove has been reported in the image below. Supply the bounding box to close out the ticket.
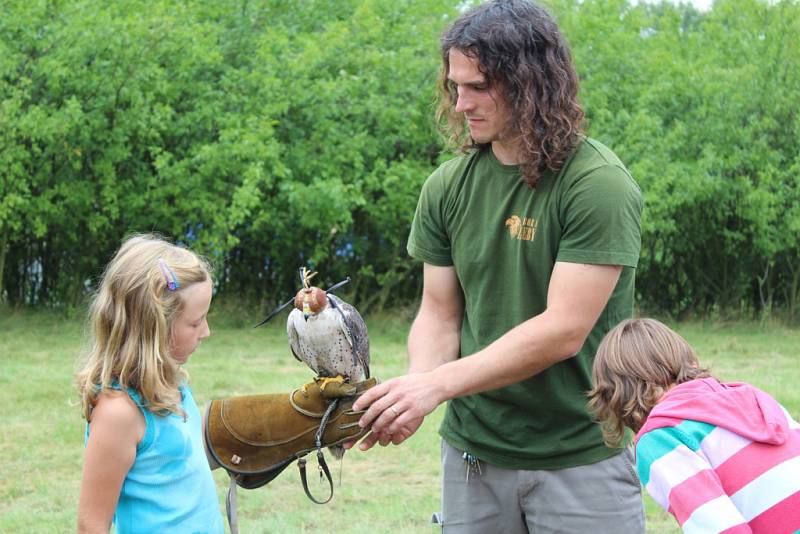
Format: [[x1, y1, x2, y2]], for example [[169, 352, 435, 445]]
[[356, 262, 622, 442]]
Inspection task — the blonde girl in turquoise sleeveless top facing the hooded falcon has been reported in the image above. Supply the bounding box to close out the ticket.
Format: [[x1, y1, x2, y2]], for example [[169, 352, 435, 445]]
[[76, 235, 223, 534]]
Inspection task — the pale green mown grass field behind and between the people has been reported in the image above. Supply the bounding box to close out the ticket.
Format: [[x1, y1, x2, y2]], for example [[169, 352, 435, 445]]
[[0, 309, 800, 534]]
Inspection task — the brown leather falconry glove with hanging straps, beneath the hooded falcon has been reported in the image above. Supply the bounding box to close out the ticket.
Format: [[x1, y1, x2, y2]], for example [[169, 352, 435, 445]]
[[204, 378, 377, 532]]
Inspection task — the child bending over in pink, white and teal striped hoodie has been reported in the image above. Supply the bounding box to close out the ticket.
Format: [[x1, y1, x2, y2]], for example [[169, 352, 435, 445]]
[[589, 319, 800, 534]]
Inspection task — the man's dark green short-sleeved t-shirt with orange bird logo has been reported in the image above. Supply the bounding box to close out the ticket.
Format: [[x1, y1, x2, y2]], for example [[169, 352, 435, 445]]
[[408, 139, 642, 469]]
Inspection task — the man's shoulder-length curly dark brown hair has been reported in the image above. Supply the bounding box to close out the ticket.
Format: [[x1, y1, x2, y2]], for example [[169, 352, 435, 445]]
[[436, 0, 584, 187]]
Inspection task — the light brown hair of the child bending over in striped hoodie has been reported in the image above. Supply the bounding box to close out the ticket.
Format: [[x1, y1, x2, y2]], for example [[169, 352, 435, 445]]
[[588, 319, 710, 447]]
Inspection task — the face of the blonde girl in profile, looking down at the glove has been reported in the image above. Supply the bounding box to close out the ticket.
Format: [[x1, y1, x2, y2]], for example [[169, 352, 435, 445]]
[[170, 279, 211, 364]]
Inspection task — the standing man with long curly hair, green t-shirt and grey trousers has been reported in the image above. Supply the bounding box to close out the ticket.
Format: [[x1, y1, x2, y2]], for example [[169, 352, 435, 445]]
[[355, 0, 644, 534]]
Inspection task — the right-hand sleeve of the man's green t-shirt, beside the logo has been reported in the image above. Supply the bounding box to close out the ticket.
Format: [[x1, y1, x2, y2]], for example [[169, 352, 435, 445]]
[[557, 164, 643, 267]]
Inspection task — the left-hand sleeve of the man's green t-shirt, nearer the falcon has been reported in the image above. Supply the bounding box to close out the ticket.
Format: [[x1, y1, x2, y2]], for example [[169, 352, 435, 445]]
[[406, 167, 453, 267]]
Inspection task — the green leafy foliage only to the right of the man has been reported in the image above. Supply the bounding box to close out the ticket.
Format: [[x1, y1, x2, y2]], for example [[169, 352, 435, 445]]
[[564, 0, 800, 314]]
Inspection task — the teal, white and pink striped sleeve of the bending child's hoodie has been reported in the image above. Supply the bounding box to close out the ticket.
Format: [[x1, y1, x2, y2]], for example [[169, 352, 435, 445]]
[[636, 427, 752, 534]]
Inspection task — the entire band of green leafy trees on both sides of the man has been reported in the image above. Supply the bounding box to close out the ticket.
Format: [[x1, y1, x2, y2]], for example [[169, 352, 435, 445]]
[[0, 0, 800, 320]]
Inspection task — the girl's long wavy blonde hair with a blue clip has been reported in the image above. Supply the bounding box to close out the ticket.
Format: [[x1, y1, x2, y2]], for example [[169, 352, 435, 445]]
[[76, 234, 211, 421]]
